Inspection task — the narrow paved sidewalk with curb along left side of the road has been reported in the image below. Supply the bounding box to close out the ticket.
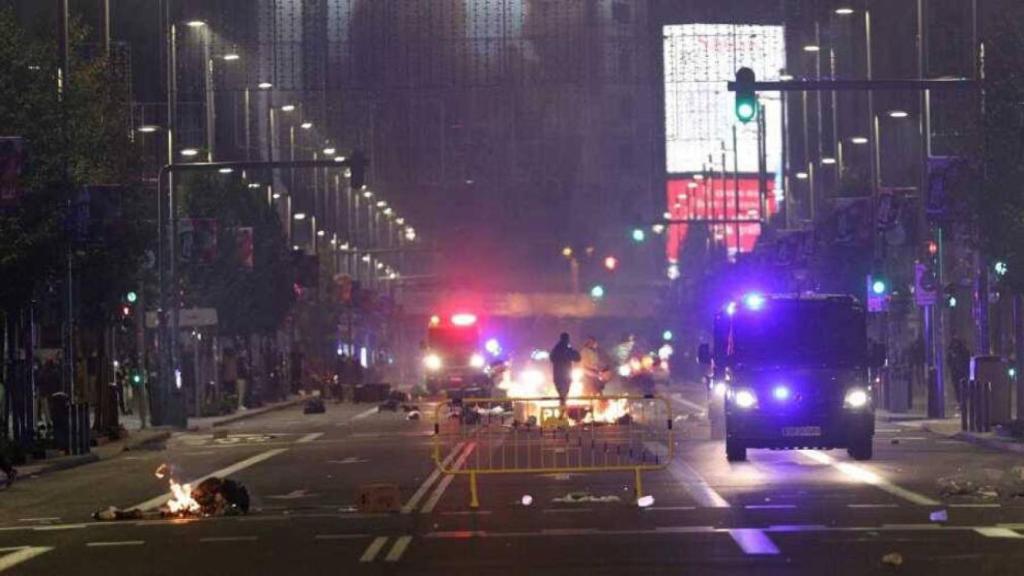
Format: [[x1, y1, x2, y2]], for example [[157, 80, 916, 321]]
[[17, 396, 305, 478]]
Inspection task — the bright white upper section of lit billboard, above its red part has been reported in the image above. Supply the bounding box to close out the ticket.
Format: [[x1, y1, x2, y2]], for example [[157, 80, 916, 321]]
[[663, 24, 785, 174]]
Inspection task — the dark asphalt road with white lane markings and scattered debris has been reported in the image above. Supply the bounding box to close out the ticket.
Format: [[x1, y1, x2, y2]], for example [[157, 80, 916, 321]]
[[0, 387, 1024, 576]]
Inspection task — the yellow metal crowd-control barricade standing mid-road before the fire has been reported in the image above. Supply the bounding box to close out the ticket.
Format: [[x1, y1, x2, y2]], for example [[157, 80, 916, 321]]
[[433, 396, 675, 508]]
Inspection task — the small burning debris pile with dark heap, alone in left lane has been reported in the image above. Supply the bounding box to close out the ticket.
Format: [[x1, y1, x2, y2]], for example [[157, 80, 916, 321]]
[[92, 464, 249, 522]]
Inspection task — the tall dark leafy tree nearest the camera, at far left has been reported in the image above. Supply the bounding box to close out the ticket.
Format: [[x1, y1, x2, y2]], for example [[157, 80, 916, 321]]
[[0, 8, 152, 436]]
